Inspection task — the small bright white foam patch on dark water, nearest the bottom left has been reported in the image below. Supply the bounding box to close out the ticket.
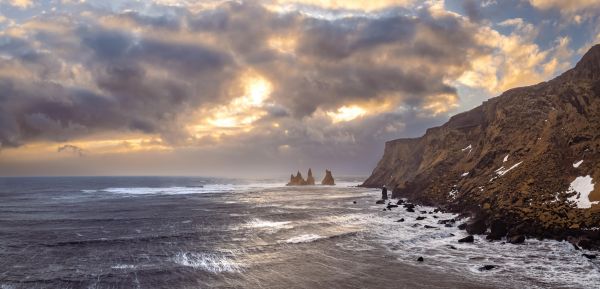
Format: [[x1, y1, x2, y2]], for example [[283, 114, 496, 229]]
[[173, 252, 241, 273]]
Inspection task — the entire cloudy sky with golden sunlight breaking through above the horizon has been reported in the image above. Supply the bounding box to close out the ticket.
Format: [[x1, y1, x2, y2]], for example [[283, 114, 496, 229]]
[[0, 0, 600, 178]]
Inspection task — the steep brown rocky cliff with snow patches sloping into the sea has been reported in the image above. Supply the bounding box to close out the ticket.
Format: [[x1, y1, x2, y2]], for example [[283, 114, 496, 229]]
[[363, 45, 600, 247]]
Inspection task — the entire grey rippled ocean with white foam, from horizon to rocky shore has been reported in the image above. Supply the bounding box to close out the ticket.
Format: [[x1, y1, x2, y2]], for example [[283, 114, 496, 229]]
[[0, 177, 600, 289]]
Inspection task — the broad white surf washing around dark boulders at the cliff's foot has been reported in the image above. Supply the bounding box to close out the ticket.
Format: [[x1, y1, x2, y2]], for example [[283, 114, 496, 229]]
[[370, 200, 600, 288]]
